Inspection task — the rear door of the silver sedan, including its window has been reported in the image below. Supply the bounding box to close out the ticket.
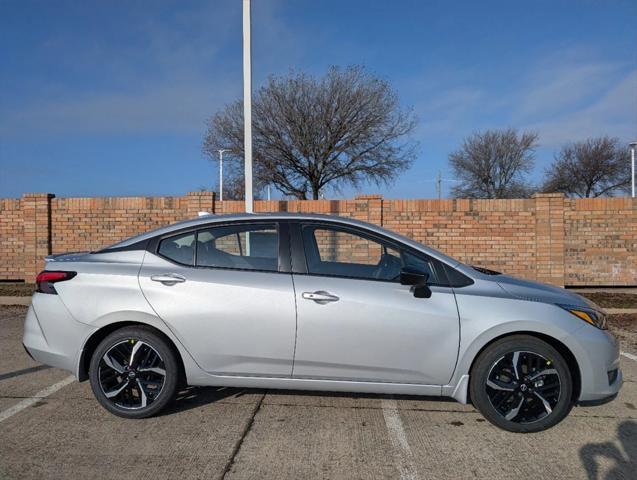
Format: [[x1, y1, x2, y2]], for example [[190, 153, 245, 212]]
[[139, 222, 296, 377]]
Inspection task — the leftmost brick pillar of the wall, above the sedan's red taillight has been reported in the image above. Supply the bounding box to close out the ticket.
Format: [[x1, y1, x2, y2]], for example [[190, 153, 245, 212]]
[[21, 193, 55, 282]]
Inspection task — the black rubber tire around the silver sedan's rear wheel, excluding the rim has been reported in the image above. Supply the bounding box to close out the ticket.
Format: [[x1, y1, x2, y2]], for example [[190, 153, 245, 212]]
[[89, 327, 179, 418]]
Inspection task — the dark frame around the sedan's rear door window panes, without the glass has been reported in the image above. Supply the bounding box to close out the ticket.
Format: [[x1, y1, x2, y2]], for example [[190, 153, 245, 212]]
[[152, 219, 292, 274]]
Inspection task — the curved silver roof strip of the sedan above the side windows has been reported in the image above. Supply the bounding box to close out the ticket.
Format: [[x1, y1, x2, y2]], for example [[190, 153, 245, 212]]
[[107, 212, 460, 266]]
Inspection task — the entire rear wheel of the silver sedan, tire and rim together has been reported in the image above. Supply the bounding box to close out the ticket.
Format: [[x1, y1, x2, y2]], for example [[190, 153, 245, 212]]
[[89, 326, 180, 419]]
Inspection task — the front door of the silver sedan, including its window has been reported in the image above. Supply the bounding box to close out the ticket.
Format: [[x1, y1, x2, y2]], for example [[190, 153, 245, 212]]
[[293, 223, 459, 385]]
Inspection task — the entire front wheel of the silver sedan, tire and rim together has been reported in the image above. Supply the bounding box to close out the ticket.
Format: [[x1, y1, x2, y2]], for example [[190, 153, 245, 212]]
[[469, 335, 573, 433]]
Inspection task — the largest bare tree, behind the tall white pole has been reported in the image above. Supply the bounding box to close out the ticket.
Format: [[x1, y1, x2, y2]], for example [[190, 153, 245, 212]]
[[203, 66, 416, 199]]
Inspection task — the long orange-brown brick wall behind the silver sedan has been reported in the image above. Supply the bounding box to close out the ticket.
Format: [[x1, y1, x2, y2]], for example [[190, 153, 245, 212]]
[[0, 192, 637, 286]]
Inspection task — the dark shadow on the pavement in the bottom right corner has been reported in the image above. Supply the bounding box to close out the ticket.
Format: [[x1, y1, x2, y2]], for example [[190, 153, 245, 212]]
[[579, 420, 637, 480]]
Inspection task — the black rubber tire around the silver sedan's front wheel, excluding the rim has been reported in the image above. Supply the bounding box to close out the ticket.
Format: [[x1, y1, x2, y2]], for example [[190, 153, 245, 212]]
[[470, 335, 573, 433]]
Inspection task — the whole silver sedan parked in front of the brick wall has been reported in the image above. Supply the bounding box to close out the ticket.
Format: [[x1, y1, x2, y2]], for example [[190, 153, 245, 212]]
[[23, 214, 622, 432]]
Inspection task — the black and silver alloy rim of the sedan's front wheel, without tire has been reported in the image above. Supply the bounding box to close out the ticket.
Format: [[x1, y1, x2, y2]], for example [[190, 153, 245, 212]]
[[485, 351, 562, 424]]
